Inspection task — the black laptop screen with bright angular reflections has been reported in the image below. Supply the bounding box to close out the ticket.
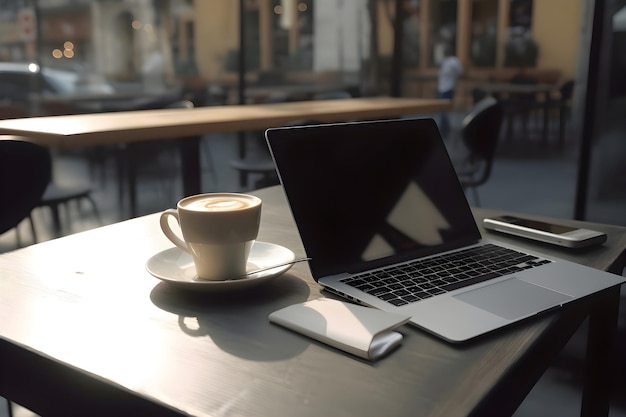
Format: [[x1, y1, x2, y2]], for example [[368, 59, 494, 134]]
[[266, 119, 480, 279]]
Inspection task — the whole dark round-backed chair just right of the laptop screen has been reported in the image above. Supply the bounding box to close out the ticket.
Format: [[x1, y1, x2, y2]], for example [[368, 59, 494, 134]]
[[455, 97, 504, 206]]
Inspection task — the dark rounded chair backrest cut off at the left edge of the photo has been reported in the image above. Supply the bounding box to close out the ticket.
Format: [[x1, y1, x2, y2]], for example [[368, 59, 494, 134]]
[[0, 136, 52, 234]]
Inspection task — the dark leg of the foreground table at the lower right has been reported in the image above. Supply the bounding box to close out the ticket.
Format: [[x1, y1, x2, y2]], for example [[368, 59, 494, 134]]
[[580, 287, 620, 417]]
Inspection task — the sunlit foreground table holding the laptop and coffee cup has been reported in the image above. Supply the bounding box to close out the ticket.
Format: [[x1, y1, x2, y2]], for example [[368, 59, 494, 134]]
[[0, 187, 626, 417]]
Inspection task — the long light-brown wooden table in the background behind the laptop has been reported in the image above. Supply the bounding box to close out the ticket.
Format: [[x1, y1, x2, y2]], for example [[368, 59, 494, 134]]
[[0, 97, 451, 214]]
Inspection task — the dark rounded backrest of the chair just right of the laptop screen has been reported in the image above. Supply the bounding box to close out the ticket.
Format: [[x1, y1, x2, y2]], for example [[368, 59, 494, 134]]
[[461, 97, 503, 182]]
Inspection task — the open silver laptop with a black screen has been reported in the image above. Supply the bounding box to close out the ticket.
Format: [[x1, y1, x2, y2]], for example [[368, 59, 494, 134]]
[[266, 118, 625, 343]]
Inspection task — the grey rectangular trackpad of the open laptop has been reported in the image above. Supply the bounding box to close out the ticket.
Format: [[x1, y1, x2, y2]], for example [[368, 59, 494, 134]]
[[454, 278, 572, 320]]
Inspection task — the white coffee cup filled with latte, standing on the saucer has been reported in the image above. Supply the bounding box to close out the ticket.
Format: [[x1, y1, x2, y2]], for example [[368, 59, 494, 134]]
[[160, 193, 261, 281]]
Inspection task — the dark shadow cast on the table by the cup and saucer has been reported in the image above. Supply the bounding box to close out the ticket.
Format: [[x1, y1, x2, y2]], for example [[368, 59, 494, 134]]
[[150, 273, 311, 361]]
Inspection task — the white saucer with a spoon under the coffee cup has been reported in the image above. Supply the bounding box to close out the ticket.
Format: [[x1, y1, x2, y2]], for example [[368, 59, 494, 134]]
[[146, 241, 295, 292]]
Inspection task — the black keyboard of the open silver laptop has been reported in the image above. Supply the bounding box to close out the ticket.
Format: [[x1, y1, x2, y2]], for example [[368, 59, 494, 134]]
[[341, 244, 552, 306]]
